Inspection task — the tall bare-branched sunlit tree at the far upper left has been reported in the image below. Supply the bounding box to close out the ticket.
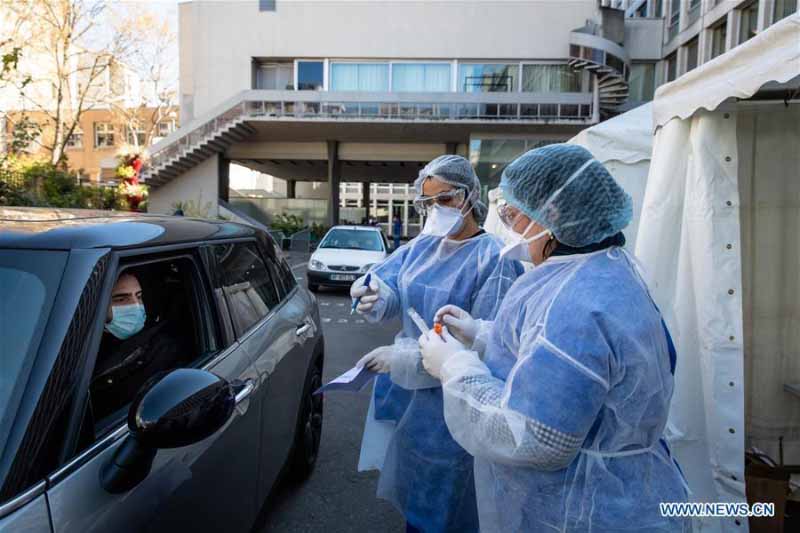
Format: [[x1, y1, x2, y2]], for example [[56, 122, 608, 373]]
[[0, 0, 134, 165]]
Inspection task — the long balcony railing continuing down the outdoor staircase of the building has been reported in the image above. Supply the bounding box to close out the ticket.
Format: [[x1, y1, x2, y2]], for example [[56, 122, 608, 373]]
[[150, 90, 593, 168]]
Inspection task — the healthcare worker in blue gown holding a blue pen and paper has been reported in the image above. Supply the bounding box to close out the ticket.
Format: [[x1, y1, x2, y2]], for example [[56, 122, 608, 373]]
[[351, 155, 523, 533]]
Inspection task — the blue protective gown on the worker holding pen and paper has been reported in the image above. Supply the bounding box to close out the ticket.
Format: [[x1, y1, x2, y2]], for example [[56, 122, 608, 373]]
[[360, 233, 523, 533]]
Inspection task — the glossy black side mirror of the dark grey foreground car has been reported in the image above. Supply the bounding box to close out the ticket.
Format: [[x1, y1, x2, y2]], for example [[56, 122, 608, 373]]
[[100, 368, 236, 494]]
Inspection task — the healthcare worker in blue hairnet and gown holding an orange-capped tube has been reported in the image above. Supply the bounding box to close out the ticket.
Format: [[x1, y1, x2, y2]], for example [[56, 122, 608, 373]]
[[419, 144, 691, 532]]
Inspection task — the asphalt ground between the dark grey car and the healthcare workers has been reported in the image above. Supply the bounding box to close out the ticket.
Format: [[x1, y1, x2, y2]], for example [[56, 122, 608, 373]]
[[261, 254, 405, 533]]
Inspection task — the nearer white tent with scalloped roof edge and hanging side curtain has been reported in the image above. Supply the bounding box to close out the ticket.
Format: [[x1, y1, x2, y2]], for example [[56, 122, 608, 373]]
[[635, 14, 800, 531]]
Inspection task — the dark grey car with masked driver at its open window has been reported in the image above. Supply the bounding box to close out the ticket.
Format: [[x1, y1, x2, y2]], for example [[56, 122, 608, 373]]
[[0, 208, 324, 533]]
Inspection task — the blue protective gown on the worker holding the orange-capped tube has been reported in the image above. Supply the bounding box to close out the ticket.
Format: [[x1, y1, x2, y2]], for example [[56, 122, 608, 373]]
[[434, 248, 690, 532]]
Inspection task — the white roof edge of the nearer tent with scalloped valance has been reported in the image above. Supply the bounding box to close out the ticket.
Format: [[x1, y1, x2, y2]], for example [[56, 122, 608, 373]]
[[653, 13, 800, 128]]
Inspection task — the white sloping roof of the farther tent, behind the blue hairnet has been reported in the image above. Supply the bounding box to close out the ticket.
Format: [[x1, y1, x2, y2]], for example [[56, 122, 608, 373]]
[[568, 104, 653, 164]]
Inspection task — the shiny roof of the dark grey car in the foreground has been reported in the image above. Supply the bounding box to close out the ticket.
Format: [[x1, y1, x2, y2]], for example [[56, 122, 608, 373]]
[[0, 207, 257, 250]]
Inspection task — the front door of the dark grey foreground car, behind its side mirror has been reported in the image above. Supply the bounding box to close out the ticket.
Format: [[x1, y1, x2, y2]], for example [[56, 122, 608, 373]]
[[47, 248, 260, 533]]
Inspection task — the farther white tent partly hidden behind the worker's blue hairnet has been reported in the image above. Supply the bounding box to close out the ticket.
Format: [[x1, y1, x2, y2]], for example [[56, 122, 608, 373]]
[[484, 104, 653, 250]]
